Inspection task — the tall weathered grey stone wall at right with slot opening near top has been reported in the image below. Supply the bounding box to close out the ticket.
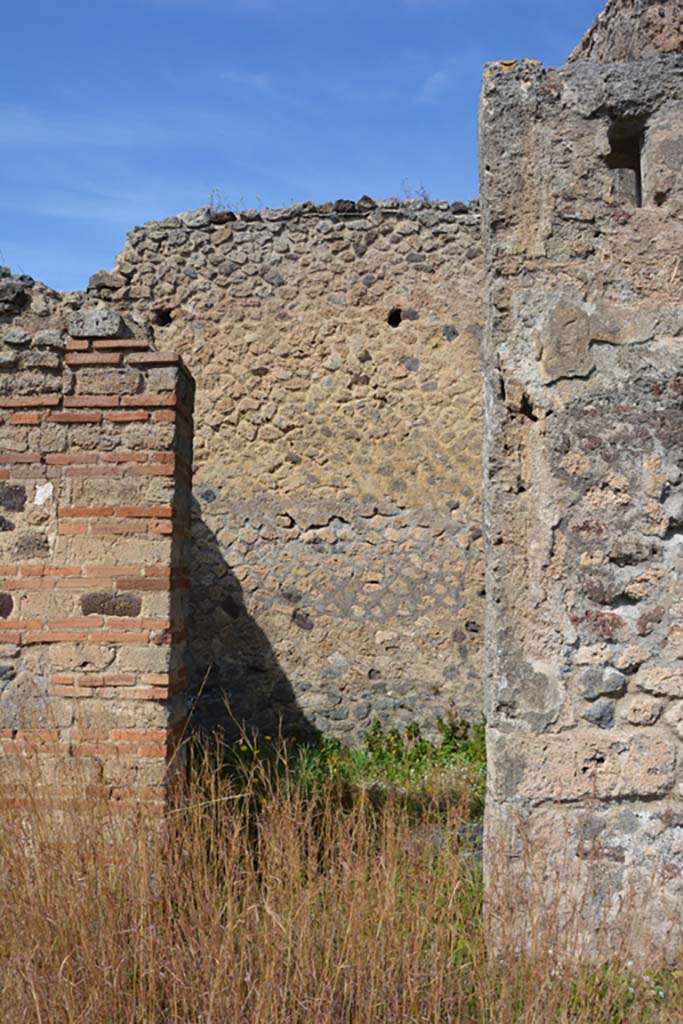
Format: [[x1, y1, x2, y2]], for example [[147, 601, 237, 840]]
[[480, 29, 683, 956]]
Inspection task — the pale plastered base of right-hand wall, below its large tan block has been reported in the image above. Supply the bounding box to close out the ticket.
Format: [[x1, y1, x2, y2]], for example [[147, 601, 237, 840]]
[[487, 801, 683, 970]]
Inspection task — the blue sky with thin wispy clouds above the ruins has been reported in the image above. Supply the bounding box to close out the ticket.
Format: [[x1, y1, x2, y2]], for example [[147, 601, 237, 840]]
[[0, 0, 603, 289]]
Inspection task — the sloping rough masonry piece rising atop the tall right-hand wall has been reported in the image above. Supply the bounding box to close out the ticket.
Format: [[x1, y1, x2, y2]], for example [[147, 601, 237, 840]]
[[568, 0, 683, 63]]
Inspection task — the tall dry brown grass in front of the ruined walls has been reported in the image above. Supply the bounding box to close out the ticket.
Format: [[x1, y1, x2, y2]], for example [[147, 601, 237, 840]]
[[0, 745, 683, 1024]]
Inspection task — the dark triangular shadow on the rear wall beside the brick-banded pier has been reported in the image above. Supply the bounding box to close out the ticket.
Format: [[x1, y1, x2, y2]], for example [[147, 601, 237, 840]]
[[187, 499, 319, 740]]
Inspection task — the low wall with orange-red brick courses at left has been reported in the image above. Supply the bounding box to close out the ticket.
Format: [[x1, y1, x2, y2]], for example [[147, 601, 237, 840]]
[[0, 272, 194, 802]]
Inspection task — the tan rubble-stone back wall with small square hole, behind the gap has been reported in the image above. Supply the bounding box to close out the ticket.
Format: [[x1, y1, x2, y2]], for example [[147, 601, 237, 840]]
[[89, 197, 483, 740]]
